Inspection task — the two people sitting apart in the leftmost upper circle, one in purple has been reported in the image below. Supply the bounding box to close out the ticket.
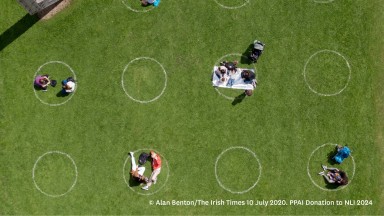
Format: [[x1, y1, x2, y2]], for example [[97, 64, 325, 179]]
[[34, 74, 76, 95]]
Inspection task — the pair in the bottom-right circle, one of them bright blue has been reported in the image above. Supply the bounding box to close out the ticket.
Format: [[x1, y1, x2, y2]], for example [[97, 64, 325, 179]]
[[319, 145, 351, 185]]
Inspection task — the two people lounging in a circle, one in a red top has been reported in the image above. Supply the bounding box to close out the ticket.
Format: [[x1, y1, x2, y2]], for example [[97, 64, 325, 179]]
[[129, 150, 161, 190]]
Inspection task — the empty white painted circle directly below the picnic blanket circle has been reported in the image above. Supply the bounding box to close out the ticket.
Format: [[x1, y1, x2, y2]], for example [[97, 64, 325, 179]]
[[215, 146, 262, 194]]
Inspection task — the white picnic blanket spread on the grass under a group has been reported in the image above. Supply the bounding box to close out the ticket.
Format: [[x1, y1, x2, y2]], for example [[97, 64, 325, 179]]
[[212, 66, 256, 90]]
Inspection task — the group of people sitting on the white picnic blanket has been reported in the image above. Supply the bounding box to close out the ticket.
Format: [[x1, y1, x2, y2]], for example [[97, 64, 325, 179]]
[[215, 61, 257, 96]]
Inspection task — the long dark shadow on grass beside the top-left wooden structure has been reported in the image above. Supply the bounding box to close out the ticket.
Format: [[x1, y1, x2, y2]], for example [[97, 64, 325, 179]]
[[0, 14, 40, 52]]
